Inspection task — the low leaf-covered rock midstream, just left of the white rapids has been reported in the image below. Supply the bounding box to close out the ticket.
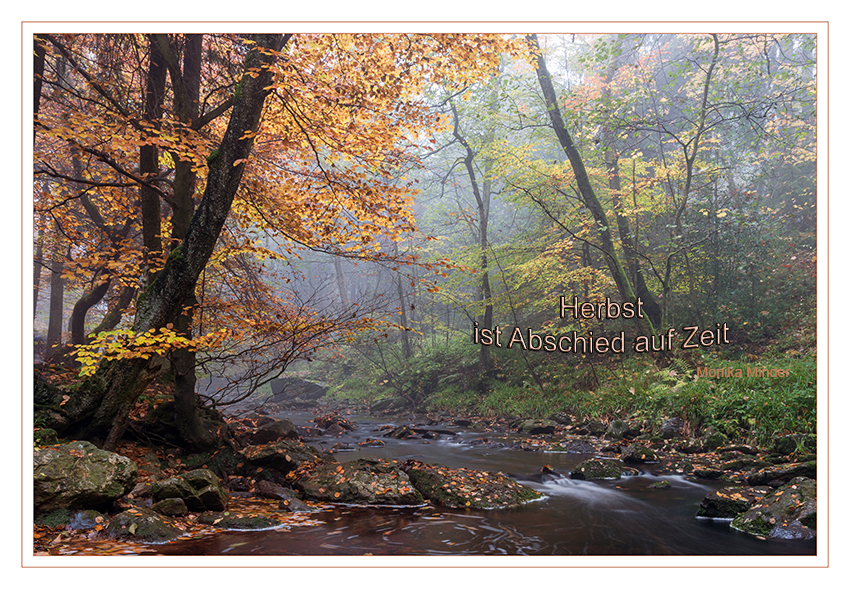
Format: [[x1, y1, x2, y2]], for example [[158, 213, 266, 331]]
[[403, 460, 543, 509]]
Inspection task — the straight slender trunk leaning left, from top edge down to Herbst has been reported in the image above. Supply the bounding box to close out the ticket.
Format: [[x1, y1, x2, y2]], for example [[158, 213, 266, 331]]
[[528, 35, 655, 335]]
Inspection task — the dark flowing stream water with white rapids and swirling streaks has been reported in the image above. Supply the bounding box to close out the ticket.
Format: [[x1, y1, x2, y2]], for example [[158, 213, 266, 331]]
[[150, 413, 816, 555]]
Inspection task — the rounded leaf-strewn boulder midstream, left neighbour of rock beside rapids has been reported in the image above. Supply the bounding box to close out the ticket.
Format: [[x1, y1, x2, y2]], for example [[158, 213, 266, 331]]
[[294, 458, 424, 505]]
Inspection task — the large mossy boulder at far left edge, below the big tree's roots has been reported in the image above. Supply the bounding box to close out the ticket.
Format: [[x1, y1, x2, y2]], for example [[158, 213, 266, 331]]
[[33, 441, 138, 513]]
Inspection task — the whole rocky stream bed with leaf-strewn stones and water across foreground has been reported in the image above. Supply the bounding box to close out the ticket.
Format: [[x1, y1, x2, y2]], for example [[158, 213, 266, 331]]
[[33, 398, 817, 555]]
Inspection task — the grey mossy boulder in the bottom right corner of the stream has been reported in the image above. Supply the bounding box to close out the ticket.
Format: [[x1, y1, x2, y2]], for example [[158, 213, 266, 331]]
[[730, 477, 817, 540]]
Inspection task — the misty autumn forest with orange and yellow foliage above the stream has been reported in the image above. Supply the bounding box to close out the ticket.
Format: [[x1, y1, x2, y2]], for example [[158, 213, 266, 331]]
[[33, 33, 817, 446]]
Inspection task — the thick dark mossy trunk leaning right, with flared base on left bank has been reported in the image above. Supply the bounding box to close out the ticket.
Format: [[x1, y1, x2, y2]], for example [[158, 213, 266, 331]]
[[36, 35, 285, 449]]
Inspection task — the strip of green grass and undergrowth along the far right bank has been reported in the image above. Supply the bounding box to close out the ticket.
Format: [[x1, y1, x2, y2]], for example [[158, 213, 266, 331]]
[[308, 340, 817, 444]]
